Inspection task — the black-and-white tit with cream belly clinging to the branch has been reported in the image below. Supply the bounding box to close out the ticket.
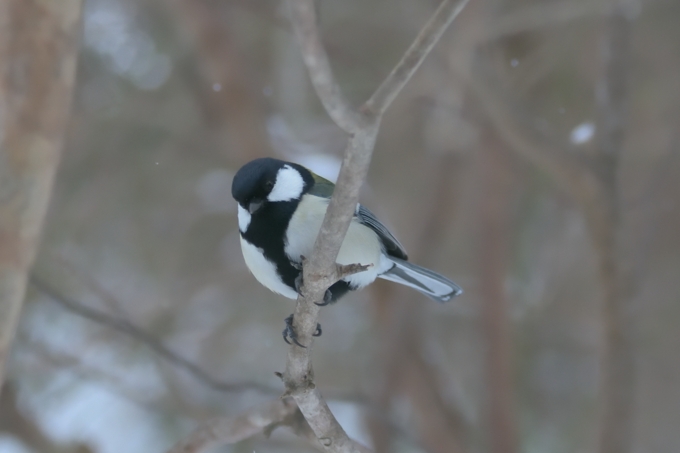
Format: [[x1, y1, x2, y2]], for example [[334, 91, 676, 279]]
[[231, 157, 463, 346]]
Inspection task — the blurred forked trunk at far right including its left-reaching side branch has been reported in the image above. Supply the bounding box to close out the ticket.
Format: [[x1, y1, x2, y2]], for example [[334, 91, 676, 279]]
[[456, 1, 638, 453]]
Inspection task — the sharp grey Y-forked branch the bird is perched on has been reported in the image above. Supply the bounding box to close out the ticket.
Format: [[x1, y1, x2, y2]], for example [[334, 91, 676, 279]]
[[282, 0, 467, 453]]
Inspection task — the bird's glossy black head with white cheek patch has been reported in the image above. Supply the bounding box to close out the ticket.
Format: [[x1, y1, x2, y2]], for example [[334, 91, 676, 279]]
[[231, 157, 314, 214]]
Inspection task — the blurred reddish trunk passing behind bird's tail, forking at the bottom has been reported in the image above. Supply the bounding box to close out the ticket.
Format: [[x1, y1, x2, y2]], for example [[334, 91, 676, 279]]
[[369, 152, 466, 453]]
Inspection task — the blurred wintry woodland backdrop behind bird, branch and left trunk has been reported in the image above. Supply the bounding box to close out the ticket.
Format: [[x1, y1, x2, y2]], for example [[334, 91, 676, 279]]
[[0, 0, 680, 453]]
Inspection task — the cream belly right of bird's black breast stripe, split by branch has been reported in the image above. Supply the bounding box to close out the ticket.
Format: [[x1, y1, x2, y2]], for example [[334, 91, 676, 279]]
[[285, 195, 393, 288]]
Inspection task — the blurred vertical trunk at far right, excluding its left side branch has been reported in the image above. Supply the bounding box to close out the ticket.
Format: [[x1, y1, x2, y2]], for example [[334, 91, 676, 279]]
[[590, 2, 635, 453]]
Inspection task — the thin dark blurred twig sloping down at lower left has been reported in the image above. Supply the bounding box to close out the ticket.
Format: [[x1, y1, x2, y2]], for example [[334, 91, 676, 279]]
[[30, 275, 276, 395]]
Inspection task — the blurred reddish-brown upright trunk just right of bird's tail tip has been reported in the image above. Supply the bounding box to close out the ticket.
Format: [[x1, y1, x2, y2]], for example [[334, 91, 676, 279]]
[[478, 127, 517, 453]]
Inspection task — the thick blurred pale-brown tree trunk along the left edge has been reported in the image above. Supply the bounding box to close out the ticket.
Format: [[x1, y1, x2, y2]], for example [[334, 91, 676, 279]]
[[0, 0, 81, 388]]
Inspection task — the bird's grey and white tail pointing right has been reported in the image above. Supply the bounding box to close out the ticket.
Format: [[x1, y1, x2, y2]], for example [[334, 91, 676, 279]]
[[378, 257, 463, 302]]
